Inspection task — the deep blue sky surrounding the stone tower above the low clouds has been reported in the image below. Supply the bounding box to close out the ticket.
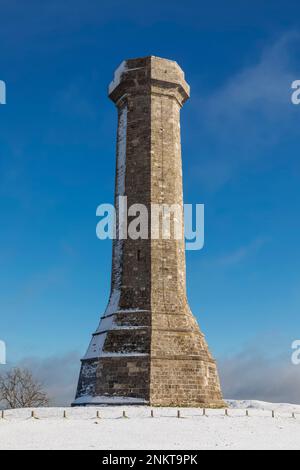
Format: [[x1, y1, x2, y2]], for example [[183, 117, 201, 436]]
[[0, 0, 300, 402]]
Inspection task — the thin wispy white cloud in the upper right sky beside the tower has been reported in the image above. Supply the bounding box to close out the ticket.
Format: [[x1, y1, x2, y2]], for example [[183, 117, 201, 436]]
[[191, 32, 300, 190]]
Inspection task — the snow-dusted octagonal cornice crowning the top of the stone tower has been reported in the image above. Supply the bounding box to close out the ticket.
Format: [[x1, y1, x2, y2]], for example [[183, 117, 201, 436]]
[[108, 56, 190, 104]]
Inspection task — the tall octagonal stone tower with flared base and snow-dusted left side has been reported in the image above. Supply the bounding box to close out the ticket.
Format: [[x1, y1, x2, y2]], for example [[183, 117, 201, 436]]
[[73, 56, 225, 407]]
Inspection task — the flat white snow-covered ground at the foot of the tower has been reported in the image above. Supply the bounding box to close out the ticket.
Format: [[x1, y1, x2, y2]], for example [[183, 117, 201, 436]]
[[0, 401, 300, 450]]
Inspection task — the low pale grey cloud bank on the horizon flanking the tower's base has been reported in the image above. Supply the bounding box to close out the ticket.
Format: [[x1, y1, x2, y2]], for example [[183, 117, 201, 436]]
[[1, 337, 300, 406]]
